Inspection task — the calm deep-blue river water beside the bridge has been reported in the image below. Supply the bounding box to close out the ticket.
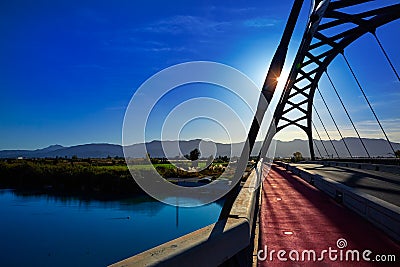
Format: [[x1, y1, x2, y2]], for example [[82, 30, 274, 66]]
[[0, 190, 221, 266]]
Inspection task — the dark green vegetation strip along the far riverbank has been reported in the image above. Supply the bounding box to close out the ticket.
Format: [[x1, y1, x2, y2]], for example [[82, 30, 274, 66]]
[[0, 157, 230, 196]]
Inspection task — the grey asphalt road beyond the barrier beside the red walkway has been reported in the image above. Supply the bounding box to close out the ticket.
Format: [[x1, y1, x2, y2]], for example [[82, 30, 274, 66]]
[[290, 164, 400, 206]]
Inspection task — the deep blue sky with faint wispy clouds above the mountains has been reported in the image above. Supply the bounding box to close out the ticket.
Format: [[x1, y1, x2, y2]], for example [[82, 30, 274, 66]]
[[0, 0, 400, 149]]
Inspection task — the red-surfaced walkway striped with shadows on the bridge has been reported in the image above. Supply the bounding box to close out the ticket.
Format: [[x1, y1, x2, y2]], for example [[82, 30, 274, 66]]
[[259, 165, 400, 266]]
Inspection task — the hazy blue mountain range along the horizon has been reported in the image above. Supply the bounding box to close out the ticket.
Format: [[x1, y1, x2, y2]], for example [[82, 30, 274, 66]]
[[0, 137, 400, 158]]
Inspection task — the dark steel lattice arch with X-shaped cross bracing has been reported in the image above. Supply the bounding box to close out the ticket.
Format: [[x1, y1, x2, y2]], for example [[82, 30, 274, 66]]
[[274, 0, 400, 159]]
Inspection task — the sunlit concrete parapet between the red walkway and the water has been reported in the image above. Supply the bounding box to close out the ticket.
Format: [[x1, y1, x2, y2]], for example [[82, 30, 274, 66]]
[[111, 165, 260, 267]]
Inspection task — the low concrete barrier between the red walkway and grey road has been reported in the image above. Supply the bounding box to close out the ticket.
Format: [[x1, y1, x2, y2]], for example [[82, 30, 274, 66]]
[[288, 164, 400, 242]]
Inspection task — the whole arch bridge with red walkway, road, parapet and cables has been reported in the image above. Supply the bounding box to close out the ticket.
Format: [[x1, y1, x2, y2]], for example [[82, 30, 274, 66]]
[[112, 0, 400, 266]]
